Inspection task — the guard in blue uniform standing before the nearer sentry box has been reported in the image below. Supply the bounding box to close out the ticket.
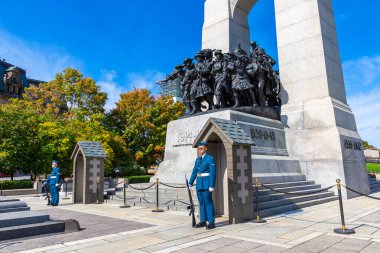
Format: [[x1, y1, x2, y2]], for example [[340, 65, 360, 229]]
[[189, 141, 216, 229]]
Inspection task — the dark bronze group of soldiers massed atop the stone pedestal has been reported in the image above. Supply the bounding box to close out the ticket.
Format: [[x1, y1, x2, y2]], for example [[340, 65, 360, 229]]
[[157, 41, 282, 115]]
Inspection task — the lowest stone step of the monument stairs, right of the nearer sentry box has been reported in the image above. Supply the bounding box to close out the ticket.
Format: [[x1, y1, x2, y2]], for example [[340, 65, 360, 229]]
[[260, 196, 338, 217]]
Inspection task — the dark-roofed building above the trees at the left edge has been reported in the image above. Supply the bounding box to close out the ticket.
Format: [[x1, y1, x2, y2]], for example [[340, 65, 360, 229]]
[[0, 59, 43, 104]]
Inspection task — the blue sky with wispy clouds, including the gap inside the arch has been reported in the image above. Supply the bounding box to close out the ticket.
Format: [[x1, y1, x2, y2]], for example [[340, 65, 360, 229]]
[[0, 0, 380, 147]]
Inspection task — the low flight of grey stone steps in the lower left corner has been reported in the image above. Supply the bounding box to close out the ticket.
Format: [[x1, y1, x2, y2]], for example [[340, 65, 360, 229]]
[[0, 197, 65, 241]]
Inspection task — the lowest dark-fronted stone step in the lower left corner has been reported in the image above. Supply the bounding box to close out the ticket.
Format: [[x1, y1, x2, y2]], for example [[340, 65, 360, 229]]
[[0, 221, 65, 241]]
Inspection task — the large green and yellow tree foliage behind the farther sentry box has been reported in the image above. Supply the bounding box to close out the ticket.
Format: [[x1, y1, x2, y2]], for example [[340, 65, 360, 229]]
[[0, 68, 132, 176]]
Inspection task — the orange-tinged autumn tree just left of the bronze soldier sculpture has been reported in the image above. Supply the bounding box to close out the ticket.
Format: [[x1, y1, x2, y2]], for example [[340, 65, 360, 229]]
[[107, 88, 185, 167]]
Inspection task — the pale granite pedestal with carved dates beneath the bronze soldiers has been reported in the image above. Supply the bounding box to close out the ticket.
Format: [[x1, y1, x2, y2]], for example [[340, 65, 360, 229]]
[[156, 107, 292, 184]]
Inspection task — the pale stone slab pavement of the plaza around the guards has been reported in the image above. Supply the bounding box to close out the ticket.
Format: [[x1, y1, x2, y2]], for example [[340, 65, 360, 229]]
[[0, 193, 380, 253]]
